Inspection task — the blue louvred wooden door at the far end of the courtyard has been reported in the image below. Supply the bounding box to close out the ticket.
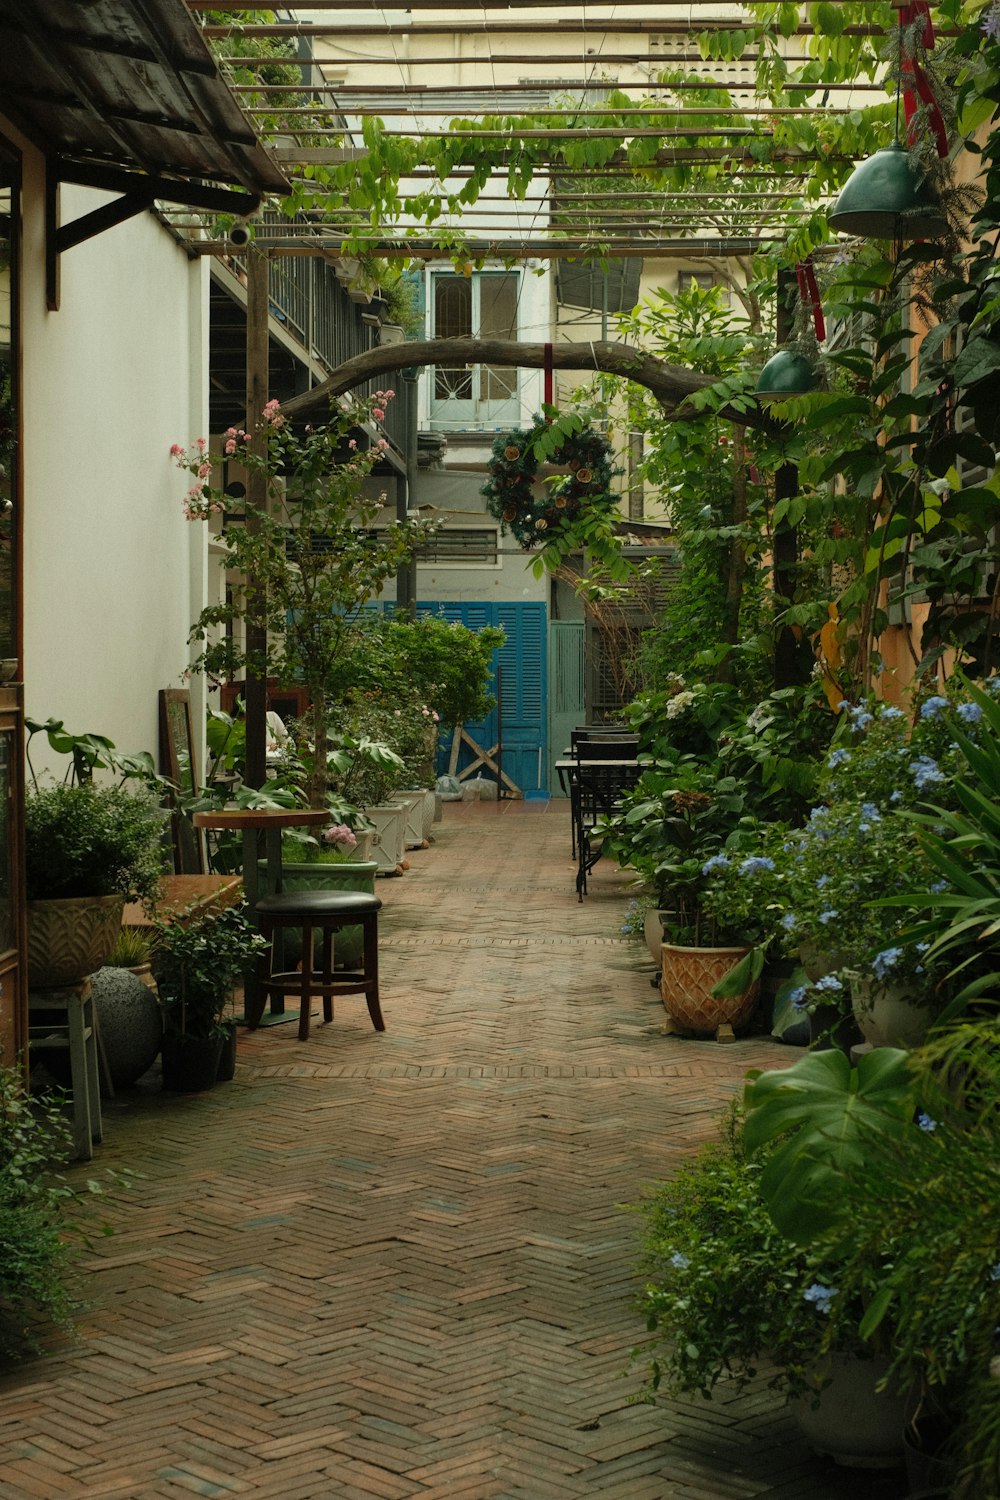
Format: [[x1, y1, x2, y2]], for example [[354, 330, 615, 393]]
[[417, 600, 549, 795]]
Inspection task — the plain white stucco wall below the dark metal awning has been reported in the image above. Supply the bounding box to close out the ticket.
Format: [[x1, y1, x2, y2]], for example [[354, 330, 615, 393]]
[[16, 141, 208, 764]]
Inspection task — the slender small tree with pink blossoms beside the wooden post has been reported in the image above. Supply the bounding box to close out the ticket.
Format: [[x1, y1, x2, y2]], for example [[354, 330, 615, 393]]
[[171, 390, 433, 807]]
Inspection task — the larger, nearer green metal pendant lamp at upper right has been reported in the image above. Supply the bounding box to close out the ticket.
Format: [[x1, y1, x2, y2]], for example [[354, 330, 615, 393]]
[[828, 141, 948, 240]]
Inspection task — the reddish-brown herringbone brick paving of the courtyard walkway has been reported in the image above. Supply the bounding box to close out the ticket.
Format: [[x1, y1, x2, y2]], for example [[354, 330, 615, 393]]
[[0, 803, 906, 1500]]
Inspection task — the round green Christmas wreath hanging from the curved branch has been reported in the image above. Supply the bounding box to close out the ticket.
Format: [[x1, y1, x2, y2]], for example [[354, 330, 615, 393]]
[[481, 419, 618, 552]]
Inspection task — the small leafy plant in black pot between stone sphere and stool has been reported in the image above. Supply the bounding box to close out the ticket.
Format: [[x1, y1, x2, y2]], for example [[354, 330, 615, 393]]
[[153, 906, 267, 1094]]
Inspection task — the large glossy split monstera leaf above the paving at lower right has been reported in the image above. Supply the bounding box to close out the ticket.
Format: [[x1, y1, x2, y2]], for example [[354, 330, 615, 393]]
[[744, 1047, 916, 1245]]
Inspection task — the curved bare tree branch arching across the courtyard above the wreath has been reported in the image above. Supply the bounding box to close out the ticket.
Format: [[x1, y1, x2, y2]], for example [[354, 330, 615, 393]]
[[282, 339, 774, 428]]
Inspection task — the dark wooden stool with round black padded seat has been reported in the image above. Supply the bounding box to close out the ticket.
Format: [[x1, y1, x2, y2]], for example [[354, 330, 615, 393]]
[[246, 891, 385, 1041]]
